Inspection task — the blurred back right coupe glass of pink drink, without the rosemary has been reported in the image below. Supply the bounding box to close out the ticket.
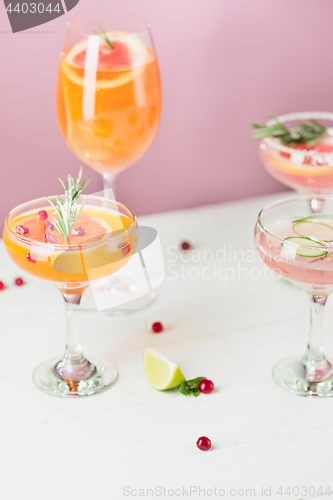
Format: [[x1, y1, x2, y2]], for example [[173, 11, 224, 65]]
[[259, 112, 333, 212]]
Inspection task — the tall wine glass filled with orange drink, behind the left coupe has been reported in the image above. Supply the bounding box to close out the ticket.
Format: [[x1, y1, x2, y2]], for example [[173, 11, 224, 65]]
[[56, 13, 161, 309]]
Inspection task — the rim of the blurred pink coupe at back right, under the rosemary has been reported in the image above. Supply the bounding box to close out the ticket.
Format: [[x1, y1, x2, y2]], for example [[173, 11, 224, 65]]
[[261, 111, 333, 160]]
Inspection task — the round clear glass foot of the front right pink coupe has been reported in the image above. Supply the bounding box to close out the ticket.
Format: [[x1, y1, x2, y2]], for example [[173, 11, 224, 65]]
[[272, 356, 333, 398]]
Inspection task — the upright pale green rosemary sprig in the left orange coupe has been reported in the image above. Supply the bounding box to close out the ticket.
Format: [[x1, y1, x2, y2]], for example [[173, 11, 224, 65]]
[[46, 167, 90, 242]]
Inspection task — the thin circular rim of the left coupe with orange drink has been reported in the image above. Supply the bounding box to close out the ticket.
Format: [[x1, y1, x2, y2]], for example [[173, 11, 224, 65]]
[[5, 194, 137, 251]]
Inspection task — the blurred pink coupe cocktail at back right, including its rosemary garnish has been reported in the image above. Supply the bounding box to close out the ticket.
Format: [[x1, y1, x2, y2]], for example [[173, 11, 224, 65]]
[[253, 112, 333, 213]]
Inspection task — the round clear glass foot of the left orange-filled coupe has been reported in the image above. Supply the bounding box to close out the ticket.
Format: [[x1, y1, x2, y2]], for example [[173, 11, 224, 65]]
[[32, 358, 117, 397]]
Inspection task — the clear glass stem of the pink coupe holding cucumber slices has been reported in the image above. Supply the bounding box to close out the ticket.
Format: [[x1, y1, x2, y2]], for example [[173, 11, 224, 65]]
[[302, 295, 332, 382]]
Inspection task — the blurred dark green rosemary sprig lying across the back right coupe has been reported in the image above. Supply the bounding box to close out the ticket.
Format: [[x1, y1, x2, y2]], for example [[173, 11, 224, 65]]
[[251, 117, 326, 146]]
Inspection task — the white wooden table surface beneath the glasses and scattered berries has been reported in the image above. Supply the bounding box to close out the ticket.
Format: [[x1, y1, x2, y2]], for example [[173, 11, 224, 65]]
[[0, 195, 333, 500]]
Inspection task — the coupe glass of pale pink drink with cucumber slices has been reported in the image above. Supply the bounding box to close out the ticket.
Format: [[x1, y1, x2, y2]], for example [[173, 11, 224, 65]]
[[254, 195, 333, 397]]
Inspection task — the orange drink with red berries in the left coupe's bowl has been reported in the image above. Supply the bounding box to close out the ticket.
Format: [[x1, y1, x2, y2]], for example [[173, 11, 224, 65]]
[[4, 196, 138, 293]]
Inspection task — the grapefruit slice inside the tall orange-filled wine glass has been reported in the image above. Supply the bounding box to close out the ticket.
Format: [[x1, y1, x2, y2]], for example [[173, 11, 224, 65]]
[[62, 31, 148, 88]]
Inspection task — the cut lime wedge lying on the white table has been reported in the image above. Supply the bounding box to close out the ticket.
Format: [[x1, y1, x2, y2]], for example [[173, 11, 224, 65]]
[[143, 348, 186, 391]]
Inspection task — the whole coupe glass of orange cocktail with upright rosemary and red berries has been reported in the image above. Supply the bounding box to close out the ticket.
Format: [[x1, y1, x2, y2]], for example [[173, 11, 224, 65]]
[[3, 170, 138, 396]]
